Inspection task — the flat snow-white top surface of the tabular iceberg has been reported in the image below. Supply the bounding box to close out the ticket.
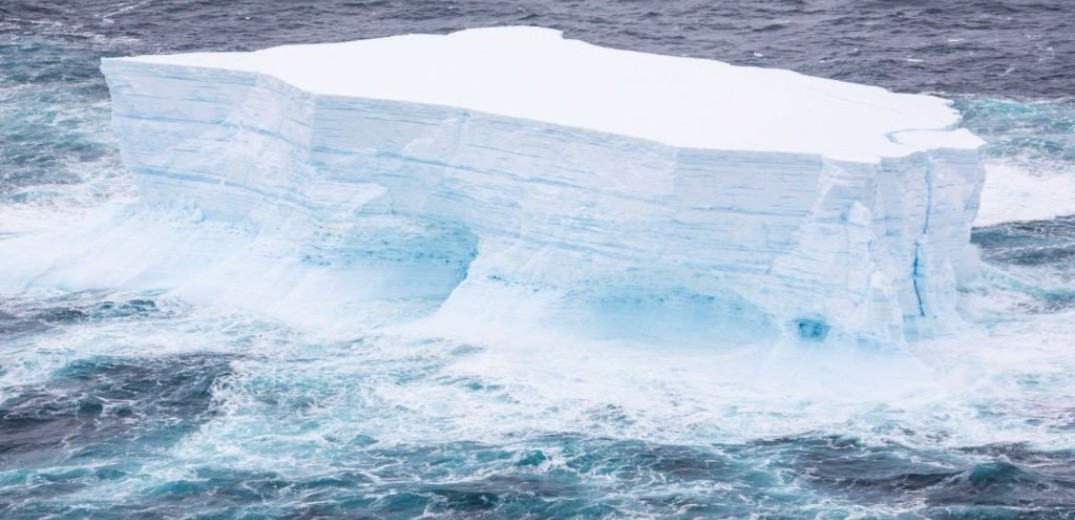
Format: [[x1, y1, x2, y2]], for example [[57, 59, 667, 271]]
[[115, 27, 981, 163]]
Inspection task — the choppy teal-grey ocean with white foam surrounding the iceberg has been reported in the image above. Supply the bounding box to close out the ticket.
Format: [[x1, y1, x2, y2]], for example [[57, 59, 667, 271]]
[[0, 0, 1075, 519]]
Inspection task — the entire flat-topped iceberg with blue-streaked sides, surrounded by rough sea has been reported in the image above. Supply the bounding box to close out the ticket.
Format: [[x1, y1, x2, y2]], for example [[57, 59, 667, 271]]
[[96, 28, 983, 345]]
